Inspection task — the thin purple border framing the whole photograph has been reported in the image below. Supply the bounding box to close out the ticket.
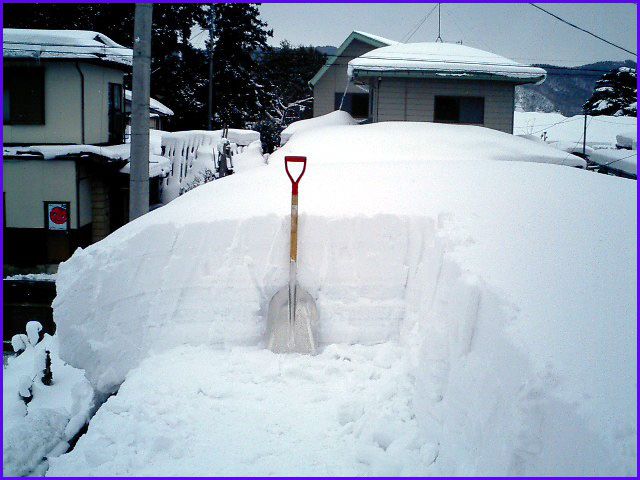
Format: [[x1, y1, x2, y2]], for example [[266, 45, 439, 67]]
[[0, 0, 640, 479]]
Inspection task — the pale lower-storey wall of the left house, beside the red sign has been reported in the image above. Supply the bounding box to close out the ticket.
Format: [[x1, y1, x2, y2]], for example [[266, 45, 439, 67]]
[[3, 160, 78, 229]]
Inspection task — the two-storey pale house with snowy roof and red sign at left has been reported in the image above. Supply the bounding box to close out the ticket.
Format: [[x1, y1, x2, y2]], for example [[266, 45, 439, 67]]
[[3, 29, 159, 267]]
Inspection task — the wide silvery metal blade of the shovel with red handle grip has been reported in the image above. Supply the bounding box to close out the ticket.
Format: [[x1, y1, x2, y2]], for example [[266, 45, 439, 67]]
[[267, 284, 318, 354]]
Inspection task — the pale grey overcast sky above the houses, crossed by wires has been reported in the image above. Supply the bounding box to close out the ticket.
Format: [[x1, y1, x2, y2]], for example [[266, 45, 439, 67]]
[[198, 3, 636, 65]]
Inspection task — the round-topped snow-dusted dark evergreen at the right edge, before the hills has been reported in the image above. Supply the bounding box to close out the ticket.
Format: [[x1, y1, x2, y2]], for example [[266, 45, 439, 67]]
[[583, 67, 638, 117]]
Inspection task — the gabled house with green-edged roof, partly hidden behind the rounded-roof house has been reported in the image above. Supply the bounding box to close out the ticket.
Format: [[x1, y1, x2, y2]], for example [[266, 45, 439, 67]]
[[309, 31, 397, 119]]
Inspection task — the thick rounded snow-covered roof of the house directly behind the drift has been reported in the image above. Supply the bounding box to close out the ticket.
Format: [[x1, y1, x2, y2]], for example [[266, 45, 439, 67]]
[[348, 42, 547, 83]]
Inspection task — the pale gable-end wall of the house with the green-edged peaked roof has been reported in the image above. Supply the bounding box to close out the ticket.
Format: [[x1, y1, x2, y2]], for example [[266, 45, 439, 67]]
[[313, 40, 376, 117]]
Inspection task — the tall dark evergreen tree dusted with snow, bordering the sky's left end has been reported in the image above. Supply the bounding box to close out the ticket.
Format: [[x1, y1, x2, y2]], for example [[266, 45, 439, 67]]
[[208, 3, 273, 128]]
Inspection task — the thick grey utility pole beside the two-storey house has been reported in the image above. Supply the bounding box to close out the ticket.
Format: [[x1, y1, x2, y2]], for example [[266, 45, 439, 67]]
[[129, 3, 153, 221]]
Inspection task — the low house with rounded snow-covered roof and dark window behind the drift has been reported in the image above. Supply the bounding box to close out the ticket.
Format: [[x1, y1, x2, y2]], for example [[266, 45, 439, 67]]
[[314, 32, 546, 133]]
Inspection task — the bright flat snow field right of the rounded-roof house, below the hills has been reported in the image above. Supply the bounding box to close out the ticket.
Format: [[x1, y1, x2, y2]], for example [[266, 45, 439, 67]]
[[513, 111, 637, 147]]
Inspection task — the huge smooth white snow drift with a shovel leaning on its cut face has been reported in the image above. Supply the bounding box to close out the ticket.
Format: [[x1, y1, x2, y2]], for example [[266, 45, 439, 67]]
[[54, 124, 637, 475]]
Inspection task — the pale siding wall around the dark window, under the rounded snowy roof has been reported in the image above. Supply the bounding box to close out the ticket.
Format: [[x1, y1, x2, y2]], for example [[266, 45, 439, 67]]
[[371, 77, 515, 133]]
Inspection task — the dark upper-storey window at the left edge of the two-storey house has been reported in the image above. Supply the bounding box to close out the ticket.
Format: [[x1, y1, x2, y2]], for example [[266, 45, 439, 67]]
[[2, 66, 44, 125]]
